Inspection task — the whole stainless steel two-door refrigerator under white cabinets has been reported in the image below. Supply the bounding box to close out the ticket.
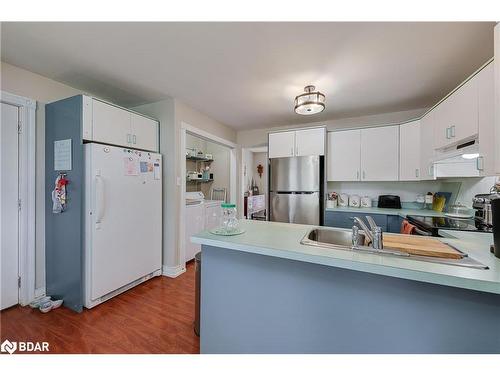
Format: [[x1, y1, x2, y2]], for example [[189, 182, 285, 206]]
[[269, 155, 324, 225]]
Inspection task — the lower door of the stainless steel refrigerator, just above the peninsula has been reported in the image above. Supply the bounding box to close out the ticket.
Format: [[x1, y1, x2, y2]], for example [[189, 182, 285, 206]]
[[270, 192, 320, 225]]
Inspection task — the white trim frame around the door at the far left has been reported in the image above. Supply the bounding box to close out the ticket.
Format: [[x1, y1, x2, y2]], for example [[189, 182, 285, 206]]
[[0, 91, 37, 305]]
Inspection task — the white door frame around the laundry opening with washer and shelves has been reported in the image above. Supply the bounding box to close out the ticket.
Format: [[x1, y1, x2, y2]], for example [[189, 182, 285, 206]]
[[177, 121, 238, 272]]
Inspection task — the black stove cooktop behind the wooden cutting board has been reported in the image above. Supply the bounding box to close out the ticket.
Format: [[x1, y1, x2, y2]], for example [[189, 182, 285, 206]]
[[406, 215, 492, 237]]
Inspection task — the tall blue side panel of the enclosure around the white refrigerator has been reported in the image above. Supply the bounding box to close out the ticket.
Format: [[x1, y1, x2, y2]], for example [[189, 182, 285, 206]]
[[45, 95, 85, 312]]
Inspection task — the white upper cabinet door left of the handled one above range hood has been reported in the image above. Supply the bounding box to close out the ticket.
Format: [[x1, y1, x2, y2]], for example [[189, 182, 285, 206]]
[[420, 109, 436, 180]]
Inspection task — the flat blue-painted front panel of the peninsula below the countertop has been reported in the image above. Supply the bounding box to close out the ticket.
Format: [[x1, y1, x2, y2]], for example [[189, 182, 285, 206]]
[[200, 245, 500, 353]]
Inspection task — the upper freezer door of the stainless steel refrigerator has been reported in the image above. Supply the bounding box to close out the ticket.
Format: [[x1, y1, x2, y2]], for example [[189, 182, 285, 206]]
[[270, 156, 320, 192]]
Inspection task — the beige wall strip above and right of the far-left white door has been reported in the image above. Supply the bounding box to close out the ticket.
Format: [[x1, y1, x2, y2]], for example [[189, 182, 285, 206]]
[[0, 62, 89, 289]]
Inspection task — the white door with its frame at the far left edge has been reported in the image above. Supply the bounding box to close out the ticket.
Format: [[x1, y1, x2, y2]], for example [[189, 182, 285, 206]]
[[0, 91, 36, 309]]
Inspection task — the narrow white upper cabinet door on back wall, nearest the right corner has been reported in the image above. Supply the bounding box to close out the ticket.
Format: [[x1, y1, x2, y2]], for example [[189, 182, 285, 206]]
[[399, 120, 420, 181]]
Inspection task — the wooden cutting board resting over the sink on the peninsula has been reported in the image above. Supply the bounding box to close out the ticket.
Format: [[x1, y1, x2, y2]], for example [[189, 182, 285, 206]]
[[384, 233, 463, 259]]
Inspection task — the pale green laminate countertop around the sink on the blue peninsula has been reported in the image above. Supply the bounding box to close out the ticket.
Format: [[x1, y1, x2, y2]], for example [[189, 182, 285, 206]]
[[191, 220, 500, 294]]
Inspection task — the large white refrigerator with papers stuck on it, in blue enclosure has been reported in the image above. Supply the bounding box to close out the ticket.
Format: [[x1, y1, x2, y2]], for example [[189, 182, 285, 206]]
[[83, 143, 162, 308]]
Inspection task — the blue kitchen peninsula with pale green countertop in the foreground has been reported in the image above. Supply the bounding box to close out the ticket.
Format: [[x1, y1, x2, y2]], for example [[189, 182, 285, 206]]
[[192, 221, 500, 353]]
